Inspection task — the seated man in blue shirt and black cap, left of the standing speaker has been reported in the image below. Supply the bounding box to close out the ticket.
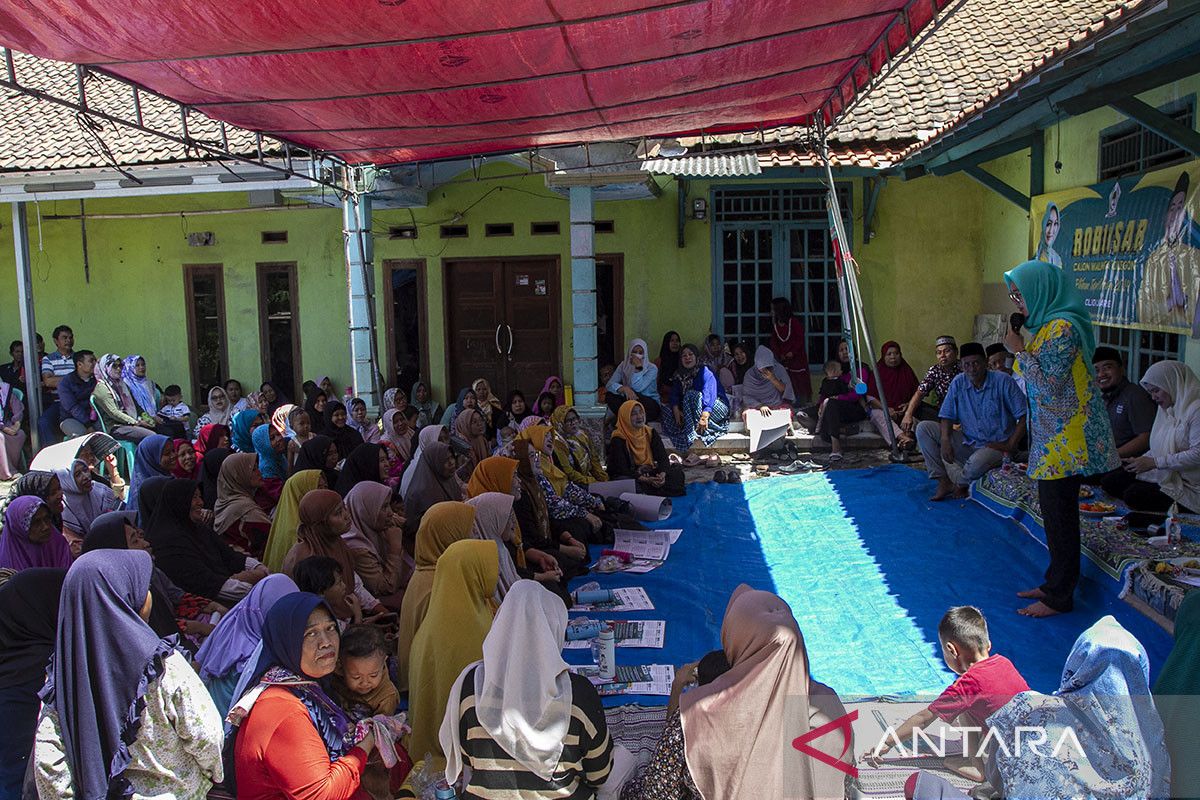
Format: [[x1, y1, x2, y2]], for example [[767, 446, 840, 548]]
[[917, 342, 1028, 500]]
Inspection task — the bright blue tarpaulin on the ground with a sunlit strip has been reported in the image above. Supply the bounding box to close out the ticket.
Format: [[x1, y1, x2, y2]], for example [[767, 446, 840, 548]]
[[565, 467, 1171, 705]]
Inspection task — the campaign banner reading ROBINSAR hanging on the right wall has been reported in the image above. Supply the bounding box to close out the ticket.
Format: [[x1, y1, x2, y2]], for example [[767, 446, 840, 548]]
[[1031, 162, 1200, 338]]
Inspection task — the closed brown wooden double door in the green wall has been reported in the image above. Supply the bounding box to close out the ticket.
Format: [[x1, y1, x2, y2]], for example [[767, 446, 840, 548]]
[[445, 258, 559, 402]]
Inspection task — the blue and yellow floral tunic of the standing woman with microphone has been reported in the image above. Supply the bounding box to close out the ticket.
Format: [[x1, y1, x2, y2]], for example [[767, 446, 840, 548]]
[[1016, 319, 1121, 481]]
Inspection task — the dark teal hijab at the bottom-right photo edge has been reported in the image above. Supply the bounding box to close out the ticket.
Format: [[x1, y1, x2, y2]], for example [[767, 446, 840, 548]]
[[1154, 591, 1200, 798]]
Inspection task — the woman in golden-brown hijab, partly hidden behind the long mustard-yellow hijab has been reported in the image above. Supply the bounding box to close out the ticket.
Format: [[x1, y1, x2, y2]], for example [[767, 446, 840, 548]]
[[396, 501, 475, 690]]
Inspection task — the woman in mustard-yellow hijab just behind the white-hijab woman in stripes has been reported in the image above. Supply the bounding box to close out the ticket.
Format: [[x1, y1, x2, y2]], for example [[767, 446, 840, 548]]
[[408, 541, 499, 764]]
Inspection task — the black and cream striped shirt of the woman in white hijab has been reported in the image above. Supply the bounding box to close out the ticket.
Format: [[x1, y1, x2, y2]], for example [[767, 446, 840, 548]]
[[458, 669, 612, 800]]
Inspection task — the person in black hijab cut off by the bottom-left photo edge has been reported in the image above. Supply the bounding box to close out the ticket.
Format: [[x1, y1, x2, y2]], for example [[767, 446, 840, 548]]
[[0, 567, 67, 798]]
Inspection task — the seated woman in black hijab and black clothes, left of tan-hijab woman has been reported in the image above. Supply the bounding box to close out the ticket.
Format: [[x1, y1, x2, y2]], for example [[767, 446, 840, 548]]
[[144, 479, 266, 604]]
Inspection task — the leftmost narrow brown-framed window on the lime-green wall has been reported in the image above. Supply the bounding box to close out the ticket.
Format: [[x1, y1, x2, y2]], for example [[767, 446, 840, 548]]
[[184, 264, 228, 409]]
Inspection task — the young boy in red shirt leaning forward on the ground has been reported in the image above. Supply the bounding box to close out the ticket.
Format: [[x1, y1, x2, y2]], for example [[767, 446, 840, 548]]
[[871, 606, 1030, 782]]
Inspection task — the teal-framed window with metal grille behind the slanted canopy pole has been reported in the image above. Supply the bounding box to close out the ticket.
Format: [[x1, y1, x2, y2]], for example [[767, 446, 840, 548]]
[[713, 185, 851, 365]]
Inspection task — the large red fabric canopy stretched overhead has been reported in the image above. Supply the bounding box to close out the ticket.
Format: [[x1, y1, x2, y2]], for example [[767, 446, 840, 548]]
[[0, 0, 949, 164]]
